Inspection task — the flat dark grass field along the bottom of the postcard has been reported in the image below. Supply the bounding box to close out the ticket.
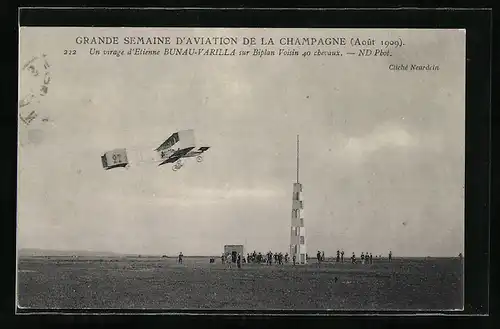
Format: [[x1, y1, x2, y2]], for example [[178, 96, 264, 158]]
[[17, 257, 463, 310]]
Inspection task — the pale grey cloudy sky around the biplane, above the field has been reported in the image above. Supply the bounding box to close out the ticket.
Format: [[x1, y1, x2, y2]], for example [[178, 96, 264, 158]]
[[18, 28, 465, 256]]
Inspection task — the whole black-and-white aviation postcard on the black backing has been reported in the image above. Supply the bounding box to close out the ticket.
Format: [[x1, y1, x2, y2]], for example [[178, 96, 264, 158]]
[[16, 27, 466, 311]]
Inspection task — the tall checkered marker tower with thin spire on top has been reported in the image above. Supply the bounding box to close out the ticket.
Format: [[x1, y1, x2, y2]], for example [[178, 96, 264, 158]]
[[290, 135, 307, 264]]
